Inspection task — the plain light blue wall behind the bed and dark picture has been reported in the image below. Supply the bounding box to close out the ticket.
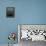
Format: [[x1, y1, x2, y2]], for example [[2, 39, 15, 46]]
[[0, 0, 46, 43]]
